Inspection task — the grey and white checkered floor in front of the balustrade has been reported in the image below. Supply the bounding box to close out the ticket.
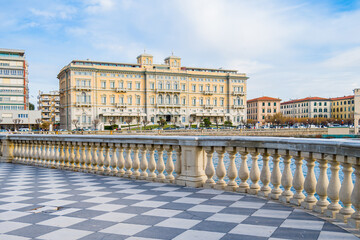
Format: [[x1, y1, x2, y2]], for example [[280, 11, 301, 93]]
[[0, 163, 358, 240]]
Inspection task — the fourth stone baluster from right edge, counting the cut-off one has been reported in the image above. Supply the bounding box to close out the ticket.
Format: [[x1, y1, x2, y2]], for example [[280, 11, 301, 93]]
[[313, 154, 329, 213]]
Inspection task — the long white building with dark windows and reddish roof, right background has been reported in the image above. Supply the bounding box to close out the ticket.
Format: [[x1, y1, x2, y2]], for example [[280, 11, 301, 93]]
[[280, 97, 331, 118]]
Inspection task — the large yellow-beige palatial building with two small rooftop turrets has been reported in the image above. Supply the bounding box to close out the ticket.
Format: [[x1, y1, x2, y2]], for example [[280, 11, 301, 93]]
[[58, 53, 248, 129]]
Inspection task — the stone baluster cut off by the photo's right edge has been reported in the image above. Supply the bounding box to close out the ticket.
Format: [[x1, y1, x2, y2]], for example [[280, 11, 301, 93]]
[[348, 158, 360, 229]]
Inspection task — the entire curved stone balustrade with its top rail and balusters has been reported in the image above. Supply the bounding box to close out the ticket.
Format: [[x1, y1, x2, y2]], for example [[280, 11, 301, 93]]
[[0, 134, 360, 229]]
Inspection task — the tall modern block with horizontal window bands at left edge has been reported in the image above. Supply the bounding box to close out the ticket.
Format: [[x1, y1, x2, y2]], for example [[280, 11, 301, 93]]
[[0, 48, 29, 111]]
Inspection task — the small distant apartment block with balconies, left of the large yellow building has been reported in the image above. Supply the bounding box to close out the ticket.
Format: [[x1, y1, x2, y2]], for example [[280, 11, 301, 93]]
[[38, 91, 60, 125]]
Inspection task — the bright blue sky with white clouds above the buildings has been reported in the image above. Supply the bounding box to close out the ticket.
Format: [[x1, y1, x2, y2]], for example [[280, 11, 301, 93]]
[[0, 0, 360, 103]]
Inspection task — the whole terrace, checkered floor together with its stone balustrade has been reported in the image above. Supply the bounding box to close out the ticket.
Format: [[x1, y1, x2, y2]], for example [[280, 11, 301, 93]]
[[0, 135, 360, 239]]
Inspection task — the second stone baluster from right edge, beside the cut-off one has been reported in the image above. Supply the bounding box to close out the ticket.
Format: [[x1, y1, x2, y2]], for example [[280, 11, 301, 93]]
[[336, 156, 354, 223]]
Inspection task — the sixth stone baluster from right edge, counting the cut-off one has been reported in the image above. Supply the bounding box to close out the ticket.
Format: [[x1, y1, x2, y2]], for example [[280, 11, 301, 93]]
[[290, 151, 305, 206]]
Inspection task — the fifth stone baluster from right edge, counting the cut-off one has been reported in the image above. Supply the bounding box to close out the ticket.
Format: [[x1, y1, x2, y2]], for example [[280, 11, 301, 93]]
[[301, 153, 317, 210]]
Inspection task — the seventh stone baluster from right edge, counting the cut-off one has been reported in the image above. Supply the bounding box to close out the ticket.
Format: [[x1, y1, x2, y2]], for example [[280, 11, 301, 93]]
[[279, 151, 294, 203]]
